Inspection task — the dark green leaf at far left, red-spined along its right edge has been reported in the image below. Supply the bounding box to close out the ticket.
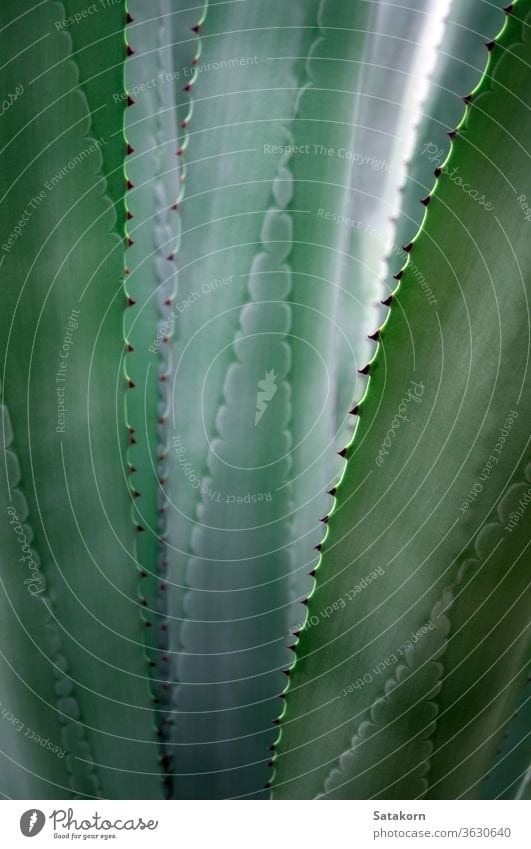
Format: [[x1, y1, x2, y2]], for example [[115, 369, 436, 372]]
[[0, 1, 161, 798]]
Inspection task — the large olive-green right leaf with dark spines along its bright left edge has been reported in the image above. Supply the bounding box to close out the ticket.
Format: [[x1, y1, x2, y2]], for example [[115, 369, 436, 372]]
[[275, 0, 531, 798]]
